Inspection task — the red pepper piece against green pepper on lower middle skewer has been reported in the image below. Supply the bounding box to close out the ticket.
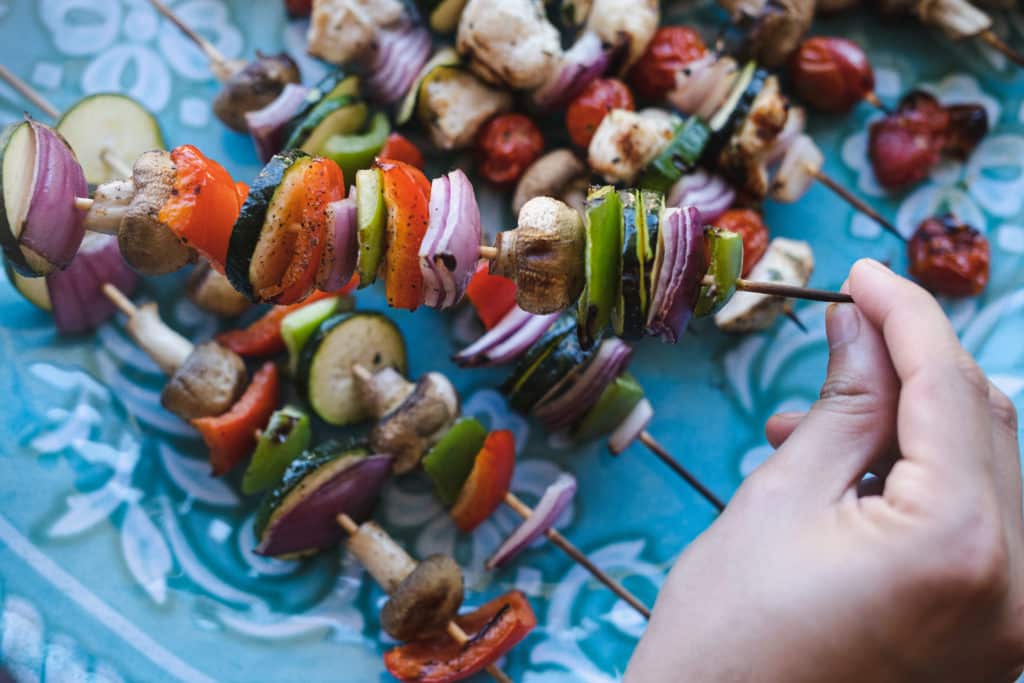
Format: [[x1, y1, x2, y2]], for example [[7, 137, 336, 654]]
[[452, 429, 515, 533]]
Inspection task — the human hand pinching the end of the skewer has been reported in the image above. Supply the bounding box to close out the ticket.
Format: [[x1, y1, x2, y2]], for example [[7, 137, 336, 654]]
[[625, 260, 1024, 683]]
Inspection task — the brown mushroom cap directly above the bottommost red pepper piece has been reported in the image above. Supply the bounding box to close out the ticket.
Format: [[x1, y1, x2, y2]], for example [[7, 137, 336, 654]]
[[381, 555, 463, 641]]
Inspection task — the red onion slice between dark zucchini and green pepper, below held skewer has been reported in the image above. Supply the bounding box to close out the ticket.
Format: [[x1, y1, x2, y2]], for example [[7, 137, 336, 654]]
[[534, 338, 633, 432]]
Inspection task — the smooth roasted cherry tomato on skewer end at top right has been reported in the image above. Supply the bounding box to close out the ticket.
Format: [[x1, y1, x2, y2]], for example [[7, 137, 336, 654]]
[[790, 36, 874, 114]]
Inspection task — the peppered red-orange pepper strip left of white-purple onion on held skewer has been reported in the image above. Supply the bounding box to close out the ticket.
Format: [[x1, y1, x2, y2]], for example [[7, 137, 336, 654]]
[[377, 159, 430, 310]]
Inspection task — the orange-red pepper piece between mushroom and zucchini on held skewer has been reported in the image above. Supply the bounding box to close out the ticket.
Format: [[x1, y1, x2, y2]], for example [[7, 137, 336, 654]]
[[159, 144, 248, 272]]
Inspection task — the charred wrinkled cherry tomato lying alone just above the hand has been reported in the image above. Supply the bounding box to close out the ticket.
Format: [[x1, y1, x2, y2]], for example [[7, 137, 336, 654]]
[[907, 215, 989, 297]]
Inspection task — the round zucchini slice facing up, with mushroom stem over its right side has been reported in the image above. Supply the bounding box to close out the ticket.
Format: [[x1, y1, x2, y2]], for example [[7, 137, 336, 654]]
[[298, 312, 406, 425]]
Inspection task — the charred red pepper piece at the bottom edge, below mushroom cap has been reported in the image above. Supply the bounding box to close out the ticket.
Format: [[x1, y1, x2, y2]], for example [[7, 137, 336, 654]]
[[384, 591, 537, 683]]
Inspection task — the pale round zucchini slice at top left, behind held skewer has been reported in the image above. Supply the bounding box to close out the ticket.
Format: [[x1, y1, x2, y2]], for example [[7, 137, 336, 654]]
[[56, 93, 166, 185]]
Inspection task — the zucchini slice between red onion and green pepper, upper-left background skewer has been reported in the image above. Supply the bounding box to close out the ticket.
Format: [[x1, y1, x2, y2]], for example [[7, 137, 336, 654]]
[[285, 76, 368, 154]]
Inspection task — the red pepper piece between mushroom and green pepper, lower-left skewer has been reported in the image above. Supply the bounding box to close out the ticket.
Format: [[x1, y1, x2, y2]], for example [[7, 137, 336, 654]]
[[191, 362, 280, 476]]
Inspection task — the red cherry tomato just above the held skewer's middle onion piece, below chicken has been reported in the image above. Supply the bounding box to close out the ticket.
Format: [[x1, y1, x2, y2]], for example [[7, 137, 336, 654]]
[[476, 114, 544, 185]]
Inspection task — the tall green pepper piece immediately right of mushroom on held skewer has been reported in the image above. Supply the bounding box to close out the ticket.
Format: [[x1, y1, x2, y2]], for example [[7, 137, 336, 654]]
[[577, 185, 623, 348]]
